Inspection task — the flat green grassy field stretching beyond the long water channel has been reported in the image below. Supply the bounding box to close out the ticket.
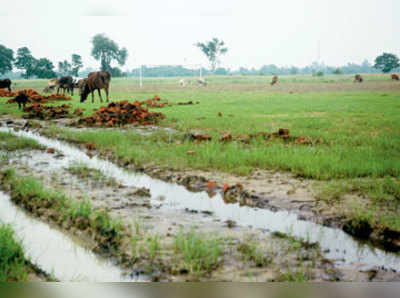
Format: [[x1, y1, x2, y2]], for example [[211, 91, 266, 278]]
[[0, 75, 400, 280]]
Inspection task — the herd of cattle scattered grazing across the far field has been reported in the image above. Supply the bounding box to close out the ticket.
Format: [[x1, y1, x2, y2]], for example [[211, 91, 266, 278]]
[[0, 71, 400, 102]]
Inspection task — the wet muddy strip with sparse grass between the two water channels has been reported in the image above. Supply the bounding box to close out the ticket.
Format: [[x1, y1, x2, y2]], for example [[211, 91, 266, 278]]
[[0, 150, 400, 281]]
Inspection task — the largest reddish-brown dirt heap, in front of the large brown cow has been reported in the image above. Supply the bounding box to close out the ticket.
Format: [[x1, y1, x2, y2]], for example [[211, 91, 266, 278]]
[[78, 100, 165, 127]]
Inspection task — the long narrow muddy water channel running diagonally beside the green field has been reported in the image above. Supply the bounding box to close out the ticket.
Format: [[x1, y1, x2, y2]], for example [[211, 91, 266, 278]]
[[0, 129, 400, 271]]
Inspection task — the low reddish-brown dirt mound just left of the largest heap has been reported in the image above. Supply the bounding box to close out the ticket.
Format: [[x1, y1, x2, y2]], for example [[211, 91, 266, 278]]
[[23, 103, 71, 120]]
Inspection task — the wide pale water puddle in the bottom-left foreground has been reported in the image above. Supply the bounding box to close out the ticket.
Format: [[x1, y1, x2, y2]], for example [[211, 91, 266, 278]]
[[0, 192, 145, 282]]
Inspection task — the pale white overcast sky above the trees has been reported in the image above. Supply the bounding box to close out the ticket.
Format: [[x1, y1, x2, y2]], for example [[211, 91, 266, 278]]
[[0, 0, 400, 69]]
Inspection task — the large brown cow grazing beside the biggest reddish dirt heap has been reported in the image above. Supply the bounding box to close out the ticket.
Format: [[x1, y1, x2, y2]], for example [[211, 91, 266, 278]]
[[80, 71, 111, 103]]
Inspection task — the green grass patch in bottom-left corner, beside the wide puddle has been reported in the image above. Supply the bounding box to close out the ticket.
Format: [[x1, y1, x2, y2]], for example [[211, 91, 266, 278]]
[[0, 223, 29, 282]]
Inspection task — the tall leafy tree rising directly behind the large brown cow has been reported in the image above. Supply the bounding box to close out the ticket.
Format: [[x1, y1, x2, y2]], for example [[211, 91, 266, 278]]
[[92, 34, 128, 72]]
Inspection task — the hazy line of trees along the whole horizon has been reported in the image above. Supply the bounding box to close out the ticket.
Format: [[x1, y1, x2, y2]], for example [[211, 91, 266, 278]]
[[0, 34, 400, 79]]
